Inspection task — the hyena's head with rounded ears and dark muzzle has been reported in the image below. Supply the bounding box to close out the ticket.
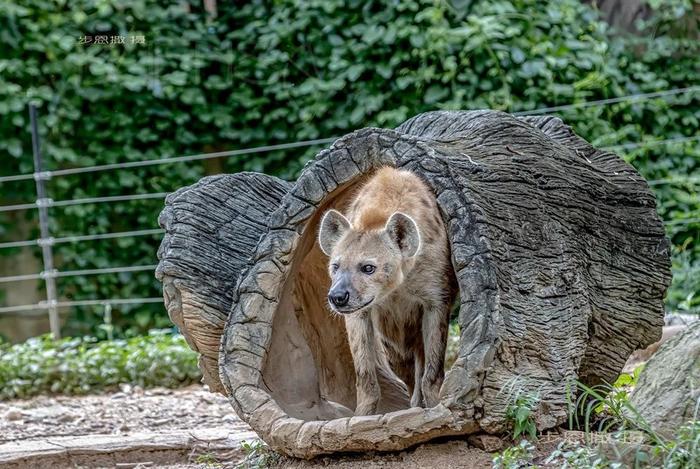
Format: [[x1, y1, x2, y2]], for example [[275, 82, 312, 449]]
[[318, 210, 421, 314]]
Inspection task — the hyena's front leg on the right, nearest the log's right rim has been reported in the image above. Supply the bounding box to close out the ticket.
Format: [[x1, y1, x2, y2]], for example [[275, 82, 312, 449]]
[[416, 304, 450, 407]]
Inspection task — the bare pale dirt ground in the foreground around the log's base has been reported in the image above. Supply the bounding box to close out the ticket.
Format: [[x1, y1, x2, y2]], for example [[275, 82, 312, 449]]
[[0, 386, 564, 469]]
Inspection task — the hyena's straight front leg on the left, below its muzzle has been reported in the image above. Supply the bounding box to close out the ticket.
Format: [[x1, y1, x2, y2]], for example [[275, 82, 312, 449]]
[[345, 311, 381, 415]]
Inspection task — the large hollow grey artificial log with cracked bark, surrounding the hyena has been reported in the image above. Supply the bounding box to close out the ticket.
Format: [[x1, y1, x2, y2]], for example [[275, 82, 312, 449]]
[[158, 111, 670, 457]]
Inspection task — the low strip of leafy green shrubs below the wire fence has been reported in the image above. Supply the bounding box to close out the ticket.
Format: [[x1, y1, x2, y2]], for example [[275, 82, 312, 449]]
[[0, 331, 200, 399]]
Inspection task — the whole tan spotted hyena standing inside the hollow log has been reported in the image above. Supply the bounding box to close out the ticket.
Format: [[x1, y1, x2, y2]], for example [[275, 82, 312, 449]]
[[319, 167, 455, 415]]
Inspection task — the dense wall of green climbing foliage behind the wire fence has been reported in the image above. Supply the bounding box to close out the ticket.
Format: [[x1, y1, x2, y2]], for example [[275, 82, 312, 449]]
[[0, 0, 700, 334]]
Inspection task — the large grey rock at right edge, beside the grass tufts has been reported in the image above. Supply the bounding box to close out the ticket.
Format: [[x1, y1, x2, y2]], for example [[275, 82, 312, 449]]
[[630, 322, 700, 434]]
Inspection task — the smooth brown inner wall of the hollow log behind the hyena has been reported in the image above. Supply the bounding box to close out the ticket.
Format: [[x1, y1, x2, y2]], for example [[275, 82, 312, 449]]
[[262, 172, 462, 420]]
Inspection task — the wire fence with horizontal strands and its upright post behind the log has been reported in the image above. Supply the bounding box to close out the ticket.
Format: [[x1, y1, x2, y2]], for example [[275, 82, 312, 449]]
[[0, 86, 700, 337]]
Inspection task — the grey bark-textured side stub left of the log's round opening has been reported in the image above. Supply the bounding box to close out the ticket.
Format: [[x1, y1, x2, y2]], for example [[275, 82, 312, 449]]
[[156, 173, 290, 392]]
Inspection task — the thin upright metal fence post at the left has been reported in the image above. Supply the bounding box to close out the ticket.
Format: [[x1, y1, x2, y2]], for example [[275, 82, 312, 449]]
[[29, 104, 61, 339]]
